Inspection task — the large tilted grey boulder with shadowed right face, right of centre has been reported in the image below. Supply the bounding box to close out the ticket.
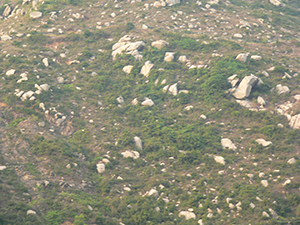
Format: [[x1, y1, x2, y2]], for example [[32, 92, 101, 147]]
[[232, 74, 259, 99]]
